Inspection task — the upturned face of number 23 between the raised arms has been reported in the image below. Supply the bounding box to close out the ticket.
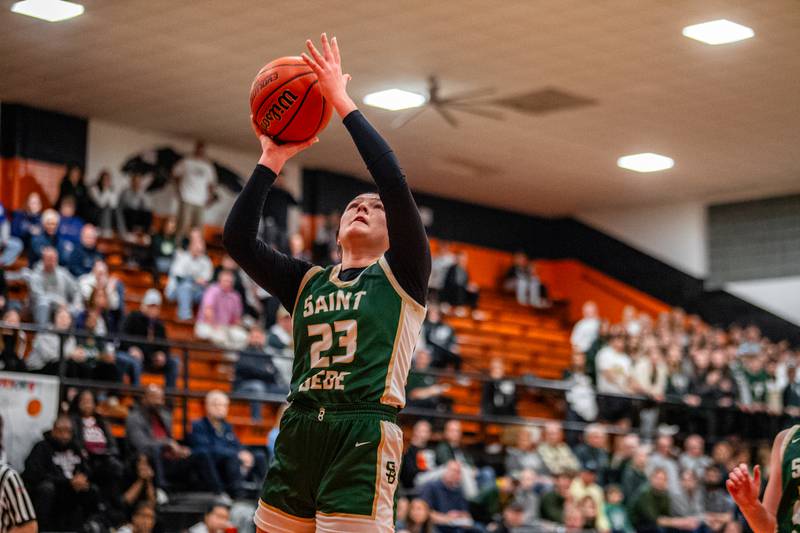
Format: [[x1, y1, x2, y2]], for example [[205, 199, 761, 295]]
[[339, 194, 389, 251]]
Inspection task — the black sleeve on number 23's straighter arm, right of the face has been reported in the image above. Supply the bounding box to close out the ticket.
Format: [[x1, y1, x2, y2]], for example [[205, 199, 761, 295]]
[[344, 110, 431, 305]]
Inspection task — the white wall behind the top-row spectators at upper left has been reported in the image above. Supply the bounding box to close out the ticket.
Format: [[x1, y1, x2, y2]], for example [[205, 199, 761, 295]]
[[86, 120, 301, 226]]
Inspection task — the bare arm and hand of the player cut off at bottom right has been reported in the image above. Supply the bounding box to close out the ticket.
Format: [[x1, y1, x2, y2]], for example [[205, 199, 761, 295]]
[[726, 430, 790, 533]]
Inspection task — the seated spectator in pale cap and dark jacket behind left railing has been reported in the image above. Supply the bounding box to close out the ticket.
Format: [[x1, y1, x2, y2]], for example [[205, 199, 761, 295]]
[[117, 289, 180, 389]]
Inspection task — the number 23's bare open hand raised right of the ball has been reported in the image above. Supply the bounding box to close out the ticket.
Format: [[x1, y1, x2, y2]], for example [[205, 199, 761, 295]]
[[302, 33, 356, 118]]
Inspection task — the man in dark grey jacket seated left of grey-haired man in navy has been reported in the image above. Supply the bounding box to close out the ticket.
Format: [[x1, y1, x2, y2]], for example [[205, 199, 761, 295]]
[[125, 385, 216, 490]]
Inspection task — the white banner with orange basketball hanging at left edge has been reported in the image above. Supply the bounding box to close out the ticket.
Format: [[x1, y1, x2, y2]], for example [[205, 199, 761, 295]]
[[0, 372, 58, 472]]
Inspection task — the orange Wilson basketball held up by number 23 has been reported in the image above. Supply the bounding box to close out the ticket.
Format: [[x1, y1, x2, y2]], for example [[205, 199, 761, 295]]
[[250, 57, 333, 143]]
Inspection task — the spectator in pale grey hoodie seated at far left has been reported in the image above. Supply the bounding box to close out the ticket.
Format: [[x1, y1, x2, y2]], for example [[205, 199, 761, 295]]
[[28, 246, 80, 325]]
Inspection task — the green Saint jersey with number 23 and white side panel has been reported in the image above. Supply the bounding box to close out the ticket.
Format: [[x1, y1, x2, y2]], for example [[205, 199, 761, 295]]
[[289, 257, 425, 408]]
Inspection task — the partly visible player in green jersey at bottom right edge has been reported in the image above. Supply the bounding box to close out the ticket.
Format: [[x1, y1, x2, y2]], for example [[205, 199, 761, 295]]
[[727, 426, 800, 533]]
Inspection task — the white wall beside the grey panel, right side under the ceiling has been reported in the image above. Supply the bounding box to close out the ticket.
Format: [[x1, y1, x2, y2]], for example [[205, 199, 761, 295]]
[[575, 202, 800, 325]]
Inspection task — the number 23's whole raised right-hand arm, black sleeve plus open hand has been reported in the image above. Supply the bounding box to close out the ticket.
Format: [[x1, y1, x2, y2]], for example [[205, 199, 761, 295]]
[[303, 34, 431, 305]]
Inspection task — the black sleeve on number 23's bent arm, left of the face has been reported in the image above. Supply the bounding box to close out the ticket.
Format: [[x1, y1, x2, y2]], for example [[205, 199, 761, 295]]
[[222, 165, 312, 313]]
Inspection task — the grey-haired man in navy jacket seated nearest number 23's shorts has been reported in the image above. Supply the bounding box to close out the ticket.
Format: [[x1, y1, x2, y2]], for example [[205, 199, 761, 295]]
[[189, 390, 267, 498]]
